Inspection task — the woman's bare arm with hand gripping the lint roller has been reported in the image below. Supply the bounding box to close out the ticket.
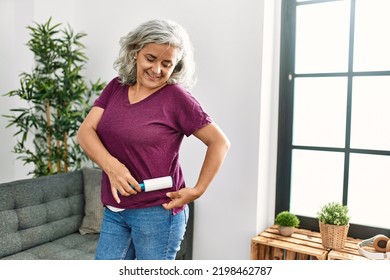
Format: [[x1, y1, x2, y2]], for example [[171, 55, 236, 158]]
[[77, 107, 141, 203]]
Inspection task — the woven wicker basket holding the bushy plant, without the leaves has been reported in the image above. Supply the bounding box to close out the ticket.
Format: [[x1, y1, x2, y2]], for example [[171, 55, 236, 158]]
[[319, 222, 349, 249]]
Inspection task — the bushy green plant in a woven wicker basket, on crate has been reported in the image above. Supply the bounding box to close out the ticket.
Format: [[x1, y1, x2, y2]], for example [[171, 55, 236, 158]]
[[317, 202, 350, 249]]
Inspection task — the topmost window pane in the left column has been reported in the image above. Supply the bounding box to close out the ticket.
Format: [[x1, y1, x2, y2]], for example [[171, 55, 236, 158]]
[[295, 1, 350, 73]]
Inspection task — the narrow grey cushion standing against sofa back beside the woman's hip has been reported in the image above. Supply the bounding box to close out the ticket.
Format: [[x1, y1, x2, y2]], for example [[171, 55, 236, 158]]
[[79, 167, 104, 235]]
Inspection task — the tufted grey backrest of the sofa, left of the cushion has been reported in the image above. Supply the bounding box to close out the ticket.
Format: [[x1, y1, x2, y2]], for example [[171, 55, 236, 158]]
[[0, 171, 84, 258]]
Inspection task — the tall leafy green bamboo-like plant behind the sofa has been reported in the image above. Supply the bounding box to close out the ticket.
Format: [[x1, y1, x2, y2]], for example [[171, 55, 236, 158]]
[[4, 18, 104, 177]]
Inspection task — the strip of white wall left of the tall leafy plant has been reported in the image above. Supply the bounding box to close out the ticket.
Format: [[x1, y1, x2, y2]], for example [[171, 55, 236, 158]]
[[0, 0, 33, 179]]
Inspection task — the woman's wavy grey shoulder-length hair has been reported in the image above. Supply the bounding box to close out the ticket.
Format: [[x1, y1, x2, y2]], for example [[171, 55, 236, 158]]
[[114, 19, 196, 89]]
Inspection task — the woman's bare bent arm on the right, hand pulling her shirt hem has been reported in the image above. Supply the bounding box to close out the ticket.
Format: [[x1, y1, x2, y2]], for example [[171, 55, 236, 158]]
[[163, 123, 230, 209]]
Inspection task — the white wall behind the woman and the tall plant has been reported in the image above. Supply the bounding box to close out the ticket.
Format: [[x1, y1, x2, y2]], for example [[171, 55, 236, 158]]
[[0, 0, 280, 259]]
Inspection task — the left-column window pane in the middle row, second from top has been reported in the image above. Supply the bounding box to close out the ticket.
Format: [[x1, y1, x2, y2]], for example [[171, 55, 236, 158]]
[[293, 77, 347, 147]]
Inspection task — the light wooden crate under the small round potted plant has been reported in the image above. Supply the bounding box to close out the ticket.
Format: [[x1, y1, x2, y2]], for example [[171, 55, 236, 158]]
[[251, 226, 329, 260]]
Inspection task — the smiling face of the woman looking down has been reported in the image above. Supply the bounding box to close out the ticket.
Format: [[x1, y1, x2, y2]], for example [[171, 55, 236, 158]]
[[136, 43, 178, 90]]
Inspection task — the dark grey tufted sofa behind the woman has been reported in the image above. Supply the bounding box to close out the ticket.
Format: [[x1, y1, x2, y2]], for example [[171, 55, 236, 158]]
[[0, 168, 194, 260]]
